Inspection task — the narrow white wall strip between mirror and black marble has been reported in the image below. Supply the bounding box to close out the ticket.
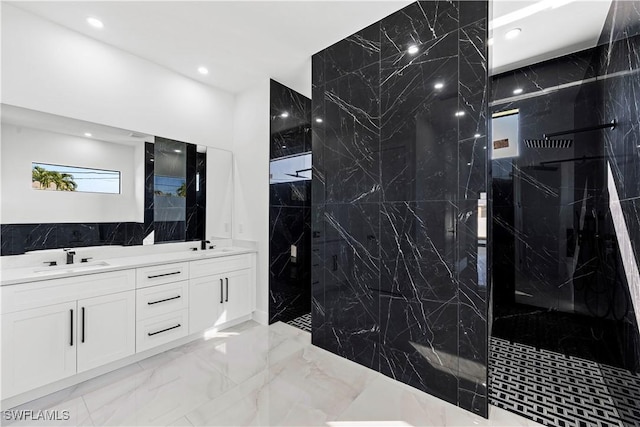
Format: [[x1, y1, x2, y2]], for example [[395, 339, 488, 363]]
[[233, 79, 269, 323]]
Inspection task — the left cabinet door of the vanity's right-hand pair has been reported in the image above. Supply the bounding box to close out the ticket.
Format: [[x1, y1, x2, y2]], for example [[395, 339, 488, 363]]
[[189, 275, 224, 334]]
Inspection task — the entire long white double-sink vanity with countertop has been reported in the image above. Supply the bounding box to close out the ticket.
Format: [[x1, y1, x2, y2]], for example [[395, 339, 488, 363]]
[[0, 241, 256, 409]]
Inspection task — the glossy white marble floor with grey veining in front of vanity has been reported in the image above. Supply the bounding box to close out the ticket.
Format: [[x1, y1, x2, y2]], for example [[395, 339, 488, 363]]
[[3, 322, 538, 427]]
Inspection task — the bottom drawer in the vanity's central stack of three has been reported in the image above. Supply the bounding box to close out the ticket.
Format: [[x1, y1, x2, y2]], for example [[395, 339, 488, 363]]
[[136, 310, 189, 353]]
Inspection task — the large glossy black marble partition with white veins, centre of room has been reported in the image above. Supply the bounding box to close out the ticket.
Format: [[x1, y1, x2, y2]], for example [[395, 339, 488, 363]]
[[312, 1, 488, 416]]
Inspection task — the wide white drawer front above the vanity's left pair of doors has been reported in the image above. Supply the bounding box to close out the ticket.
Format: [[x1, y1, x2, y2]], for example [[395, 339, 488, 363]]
[[0, 269, 136, 313]]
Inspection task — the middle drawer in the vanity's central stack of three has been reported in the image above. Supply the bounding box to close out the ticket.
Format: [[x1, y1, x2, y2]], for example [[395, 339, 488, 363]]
[[136, 280, 189, 320]]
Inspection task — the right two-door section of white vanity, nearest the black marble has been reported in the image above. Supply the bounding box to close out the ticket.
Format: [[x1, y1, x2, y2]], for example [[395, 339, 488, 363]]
[[189, 254, 255, 333]]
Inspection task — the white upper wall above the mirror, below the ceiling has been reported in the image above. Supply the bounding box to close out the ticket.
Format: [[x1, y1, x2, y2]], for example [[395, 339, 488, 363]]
[[1, 2, 234, 150]]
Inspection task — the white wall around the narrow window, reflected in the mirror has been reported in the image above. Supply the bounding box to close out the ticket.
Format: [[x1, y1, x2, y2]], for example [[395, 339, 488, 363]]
[[0, 123, 144, 224]]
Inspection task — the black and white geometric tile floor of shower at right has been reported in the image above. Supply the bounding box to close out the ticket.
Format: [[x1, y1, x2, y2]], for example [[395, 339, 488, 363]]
[[489, 337, 640, 427]]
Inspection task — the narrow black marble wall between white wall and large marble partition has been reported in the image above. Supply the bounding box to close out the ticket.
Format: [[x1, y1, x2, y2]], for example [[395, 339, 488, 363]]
[[269, 80, 311, 323]]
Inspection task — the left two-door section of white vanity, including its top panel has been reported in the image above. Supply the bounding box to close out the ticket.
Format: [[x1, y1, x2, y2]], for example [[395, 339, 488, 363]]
[[1, 270, 135, 397]]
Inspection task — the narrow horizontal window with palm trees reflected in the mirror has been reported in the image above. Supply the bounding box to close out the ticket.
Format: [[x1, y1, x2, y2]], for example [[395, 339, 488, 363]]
[[31, 162, 120, 194]]
